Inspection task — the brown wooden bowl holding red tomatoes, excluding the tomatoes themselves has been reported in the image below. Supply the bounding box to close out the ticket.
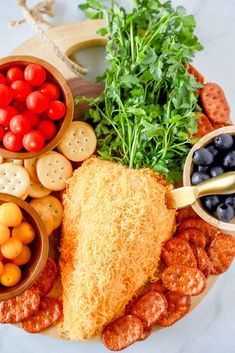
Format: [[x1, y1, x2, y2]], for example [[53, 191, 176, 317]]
[[0, 55, 74, 159]]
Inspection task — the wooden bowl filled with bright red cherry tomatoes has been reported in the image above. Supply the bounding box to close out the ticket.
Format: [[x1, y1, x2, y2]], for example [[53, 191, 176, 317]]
[[0, 56, 74, 159]]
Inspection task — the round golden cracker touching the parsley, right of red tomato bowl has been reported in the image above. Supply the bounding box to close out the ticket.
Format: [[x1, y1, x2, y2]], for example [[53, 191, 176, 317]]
[[58, 121, 97, 162]]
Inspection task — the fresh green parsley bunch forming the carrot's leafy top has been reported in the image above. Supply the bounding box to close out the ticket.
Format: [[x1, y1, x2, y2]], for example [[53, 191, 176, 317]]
[[80, 0, 202, 182]]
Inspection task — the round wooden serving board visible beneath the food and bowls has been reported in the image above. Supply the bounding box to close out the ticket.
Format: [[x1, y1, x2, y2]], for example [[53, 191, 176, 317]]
[[8, 20, 218, 340]]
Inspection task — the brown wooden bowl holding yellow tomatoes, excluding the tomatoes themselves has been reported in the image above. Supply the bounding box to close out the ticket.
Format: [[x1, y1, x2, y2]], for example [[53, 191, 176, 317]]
[[0, 193, 49, 301]]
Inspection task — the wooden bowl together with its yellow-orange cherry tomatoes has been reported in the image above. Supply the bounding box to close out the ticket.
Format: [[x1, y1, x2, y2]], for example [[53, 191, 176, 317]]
[[0, 193, 49, 301]]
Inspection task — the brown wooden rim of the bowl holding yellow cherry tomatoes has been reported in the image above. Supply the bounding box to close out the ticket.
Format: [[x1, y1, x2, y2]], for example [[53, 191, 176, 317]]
[[0, 193, 49, 301]]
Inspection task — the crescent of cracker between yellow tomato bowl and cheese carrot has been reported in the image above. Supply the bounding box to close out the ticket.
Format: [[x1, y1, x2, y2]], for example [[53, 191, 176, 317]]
[[31, 195, 64, 229]]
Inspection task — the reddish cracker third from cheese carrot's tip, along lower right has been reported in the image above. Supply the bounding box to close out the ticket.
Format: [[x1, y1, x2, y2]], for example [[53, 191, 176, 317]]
[[157, 292, 191, 327]]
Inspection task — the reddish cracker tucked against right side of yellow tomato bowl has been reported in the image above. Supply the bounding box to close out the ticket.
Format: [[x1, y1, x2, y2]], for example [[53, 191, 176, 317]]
[[35, 258, 57, 297]]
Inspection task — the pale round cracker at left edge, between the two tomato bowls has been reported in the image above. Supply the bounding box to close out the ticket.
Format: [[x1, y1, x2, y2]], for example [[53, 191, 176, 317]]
[[0, 163, 30, 197]]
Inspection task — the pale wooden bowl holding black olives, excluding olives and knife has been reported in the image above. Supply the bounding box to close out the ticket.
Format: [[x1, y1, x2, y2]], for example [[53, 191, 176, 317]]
[[183, 126, 235, 232]]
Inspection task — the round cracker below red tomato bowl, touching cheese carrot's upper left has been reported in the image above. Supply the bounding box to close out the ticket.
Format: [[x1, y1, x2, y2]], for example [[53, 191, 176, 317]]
[[36, 152, 73, 191]]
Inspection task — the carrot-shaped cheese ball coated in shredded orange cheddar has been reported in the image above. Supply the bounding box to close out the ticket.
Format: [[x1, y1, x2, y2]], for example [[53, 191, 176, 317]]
[[59, 158, 175, 340]]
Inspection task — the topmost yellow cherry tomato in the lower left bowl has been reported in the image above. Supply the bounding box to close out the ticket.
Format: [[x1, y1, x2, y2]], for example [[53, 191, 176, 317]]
[[0, 202, 22, 227]]
